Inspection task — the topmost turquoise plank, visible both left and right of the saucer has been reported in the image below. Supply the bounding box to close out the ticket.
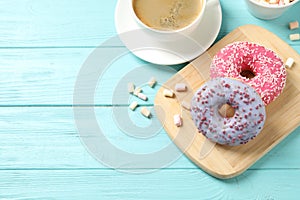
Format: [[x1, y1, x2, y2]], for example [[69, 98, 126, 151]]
[[0, 0, 300, 47]]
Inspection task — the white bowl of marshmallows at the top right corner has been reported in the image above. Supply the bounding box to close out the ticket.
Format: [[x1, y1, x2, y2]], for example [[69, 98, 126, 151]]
[[245, 0, 299, 20]]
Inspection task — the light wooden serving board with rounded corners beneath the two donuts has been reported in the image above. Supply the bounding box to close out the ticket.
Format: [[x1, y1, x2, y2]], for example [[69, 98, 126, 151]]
[[155, 25, 300, 179]]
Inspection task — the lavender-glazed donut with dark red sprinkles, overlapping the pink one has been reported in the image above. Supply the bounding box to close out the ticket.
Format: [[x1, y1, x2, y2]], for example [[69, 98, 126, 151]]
[[191, 78, 266, 146]]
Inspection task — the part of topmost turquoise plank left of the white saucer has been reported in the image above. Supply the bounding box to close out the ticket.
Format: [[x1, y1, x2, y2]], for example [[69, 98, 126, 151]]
[[0, 0, 116, 47]]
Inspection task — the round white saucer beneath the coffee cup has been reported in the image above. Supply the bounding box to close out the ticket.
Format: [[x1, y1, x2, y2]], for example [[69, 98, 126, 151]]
[[115, 0, 222, 65]]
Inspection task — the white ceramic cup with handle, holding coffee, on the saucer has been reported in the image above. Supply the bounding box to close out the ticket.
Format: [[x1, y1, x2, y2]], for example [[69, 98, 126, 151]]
[[130, 0, 218, 40]]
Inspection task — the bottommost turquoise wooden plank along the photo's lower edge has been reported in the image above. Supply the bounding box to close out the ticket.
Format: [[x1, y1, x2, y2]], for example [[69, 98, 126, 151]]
[[0, 168, 300, 200]]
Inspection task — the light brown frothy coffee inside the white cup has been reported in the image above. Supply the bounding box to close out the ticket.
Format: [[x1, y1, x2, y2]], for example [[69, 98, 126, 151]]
[[132, 0, 203, 30]]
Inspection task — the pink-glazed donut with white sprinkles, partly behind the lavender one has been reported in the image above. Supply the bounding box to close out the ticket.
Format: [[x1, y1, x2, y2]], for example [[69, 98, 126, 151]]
[[210, 42, 286, 105]]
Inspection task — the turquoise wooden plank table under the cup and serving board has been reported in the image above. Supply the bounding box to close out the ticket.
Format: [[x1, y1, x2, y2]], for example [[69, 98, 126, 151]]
[[0, 0, 300, 200]]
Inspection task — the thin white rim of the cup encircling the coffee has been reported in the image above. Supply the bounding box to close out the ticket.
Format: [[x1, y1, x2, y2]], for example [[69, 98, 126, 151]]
[[130, 0, 207, 34]]
